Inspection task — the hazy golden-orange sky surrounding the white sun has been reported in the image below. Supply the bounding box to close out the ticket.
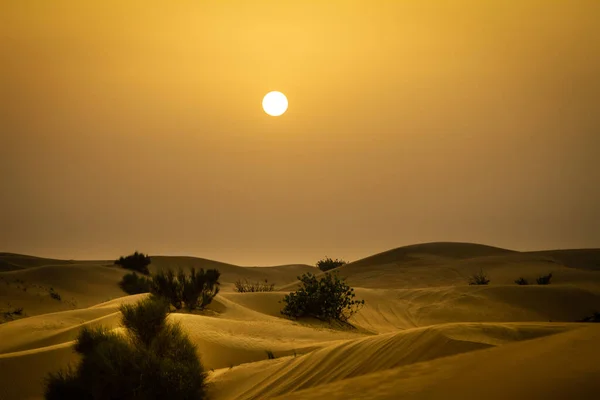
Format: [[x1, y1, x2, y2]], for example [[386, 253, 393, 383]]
[[0, 0, 600, 265]]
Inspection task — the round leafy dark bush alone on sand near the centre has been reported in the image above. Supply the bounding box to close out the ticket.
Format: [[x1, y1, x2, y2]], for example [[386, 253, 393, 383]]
[[281, 273, 365, 321]]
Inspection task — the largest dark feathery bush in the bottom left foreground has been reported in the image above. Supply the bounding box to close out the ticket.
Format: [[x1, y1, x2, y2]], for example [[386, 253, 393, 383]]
[[45, 298, 206, 400]]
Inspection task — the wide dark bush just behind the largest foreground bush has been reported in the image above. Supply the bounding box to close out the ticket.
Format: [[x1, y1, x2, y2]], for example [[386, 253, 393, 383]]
[[150, 268, 221, 311]]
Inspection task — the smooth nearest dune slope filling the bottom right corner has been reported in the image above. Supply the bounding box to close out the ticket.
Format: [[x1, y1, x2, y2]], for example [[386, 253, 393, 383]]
[[268, 326, 600, 400]]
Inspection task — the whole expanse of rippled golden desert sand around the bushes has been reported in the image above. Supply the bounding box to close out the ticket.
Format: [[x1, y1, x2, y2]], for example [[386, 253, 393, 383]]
[[0, 243, 600, 400]]
